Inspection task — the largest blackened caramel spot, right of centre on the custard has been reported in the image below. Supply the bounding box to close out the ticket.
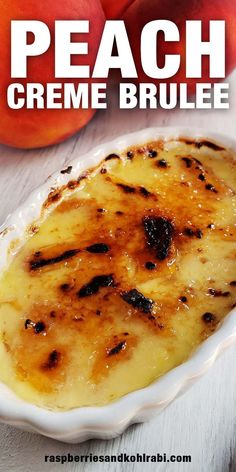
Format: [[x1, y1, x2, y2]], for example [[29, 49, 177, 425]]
[[143, 216, 174, 261]]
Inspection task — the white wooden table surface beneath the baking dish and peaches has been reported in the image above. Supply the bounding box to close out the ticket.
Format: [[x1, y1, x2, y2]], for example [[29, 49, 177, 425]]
[[0, 72, 236, 472]]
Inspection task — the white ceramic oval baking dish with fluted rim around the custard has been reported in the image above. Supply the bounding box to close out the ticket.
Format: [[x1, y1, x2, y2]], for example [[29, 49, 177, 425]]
[[0, 128, 236, 443]]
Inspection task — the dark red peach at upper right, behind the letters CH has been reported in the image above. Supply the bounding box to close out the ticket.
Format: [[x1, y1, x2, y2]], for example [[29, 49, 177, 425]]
[[123, 0, 236, 94]]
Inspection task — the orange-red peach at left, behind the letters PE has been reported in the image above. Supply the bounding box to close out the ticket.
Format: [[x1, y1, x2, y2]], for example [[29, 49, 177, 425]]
[[0, 0, 105, 148]]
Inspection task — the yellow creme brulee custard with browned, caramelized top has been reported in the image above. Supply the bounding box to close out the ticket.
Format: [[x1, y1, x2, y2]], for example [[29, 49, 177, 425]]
[[0, 139, 236, 410]]
